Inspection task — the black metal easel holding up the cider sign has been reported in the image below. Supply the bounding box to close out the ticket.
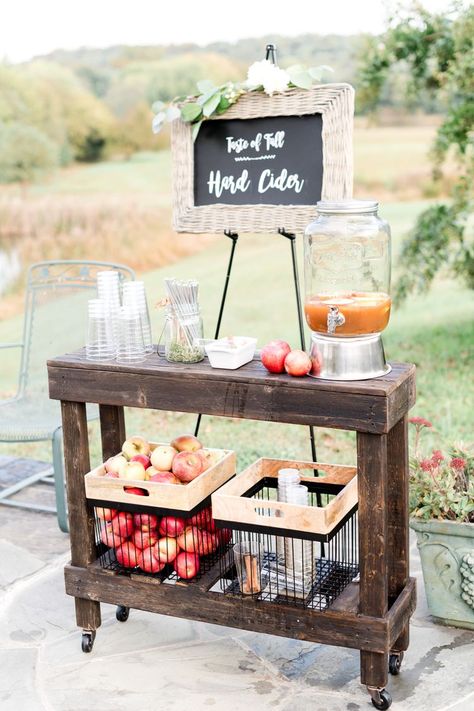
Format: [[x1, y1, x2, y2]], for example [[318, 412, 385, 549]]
[[194, 44, 317, 468]]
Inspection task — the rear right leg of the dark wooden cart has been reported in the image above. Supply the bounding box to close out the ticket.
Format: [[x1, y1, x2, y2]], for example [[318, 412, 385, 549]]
[[387, 416, 410, 660]]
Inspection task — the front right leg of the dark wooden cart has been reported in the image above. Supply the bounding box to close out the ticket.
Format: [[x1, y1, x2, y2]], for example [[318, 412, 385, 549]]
[[357, 432, 388, 700]]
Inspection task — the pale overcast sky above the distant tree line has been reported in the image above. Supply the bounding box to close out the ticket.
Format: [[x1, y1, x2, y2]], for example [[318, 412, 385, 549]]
[[0, 0, 450, 62]]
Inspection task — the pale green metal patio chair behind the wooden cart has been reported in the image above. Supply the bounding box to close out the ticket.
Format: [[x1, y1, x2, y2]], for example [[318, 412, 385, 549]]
[[0, 260, 135, 532]]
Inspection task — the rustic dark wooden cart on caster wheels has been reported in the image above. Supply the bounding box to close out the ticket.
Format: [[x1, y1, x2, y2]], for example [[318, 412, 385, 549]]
[[48, 351, 416, 709]]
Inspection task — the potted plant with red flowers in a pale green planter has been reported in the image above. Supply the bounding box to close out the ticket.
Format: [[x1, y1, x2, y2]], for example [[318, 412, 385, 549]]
[[410, 417, 474, 629]]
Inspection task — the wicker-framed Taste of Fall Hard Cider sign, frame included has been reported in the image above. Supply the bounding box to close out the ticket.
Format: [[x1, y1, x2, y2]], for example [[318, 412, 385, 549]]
[[171, 84, 354, 233]]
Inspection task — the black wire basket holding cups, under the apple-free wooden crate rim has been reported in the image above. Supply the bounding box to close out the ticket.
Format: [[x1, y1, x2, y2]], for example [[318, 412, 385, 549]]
[[213, 477, 359, 611]]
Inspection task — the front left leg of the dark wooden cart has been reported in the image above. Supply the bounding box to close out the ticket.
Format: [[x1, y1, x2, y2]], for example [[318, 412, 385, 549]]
[[61, 401, 101, 636]]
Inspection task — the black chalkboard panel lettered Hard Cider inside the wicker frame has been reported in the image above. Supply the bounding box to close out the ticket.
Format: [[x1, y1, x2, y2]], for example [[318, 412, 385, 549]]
[[194, 114, 323, 206]]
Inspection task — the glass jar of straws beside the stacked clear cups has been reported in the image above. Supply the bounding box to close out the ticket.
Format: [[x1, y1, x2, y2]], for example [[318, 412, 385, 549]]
[[165, 279, 205, 363]]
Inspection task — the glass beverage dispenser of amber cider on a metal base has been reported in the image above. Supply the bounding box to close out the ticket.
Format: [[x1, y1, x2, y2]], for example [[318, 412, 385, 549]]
[[305, 200, 391, 380]]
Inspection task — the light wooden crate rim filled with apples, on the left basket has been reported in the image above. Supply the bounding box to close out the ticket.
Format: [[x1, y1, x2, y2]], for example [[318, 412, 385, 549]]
[[84, 442, 236, 513]]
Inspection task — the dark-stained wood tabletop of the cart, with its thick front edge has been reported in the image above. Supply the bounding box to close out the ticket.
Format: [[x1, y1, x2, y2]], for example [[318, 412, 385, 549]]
[[48, 349, 415, 433]]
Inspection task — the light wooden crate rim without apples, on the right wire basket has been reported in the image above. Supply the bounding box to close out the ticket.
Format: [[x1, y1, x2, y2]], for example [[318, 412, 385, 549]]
[[212, 458, 357, 536]]
